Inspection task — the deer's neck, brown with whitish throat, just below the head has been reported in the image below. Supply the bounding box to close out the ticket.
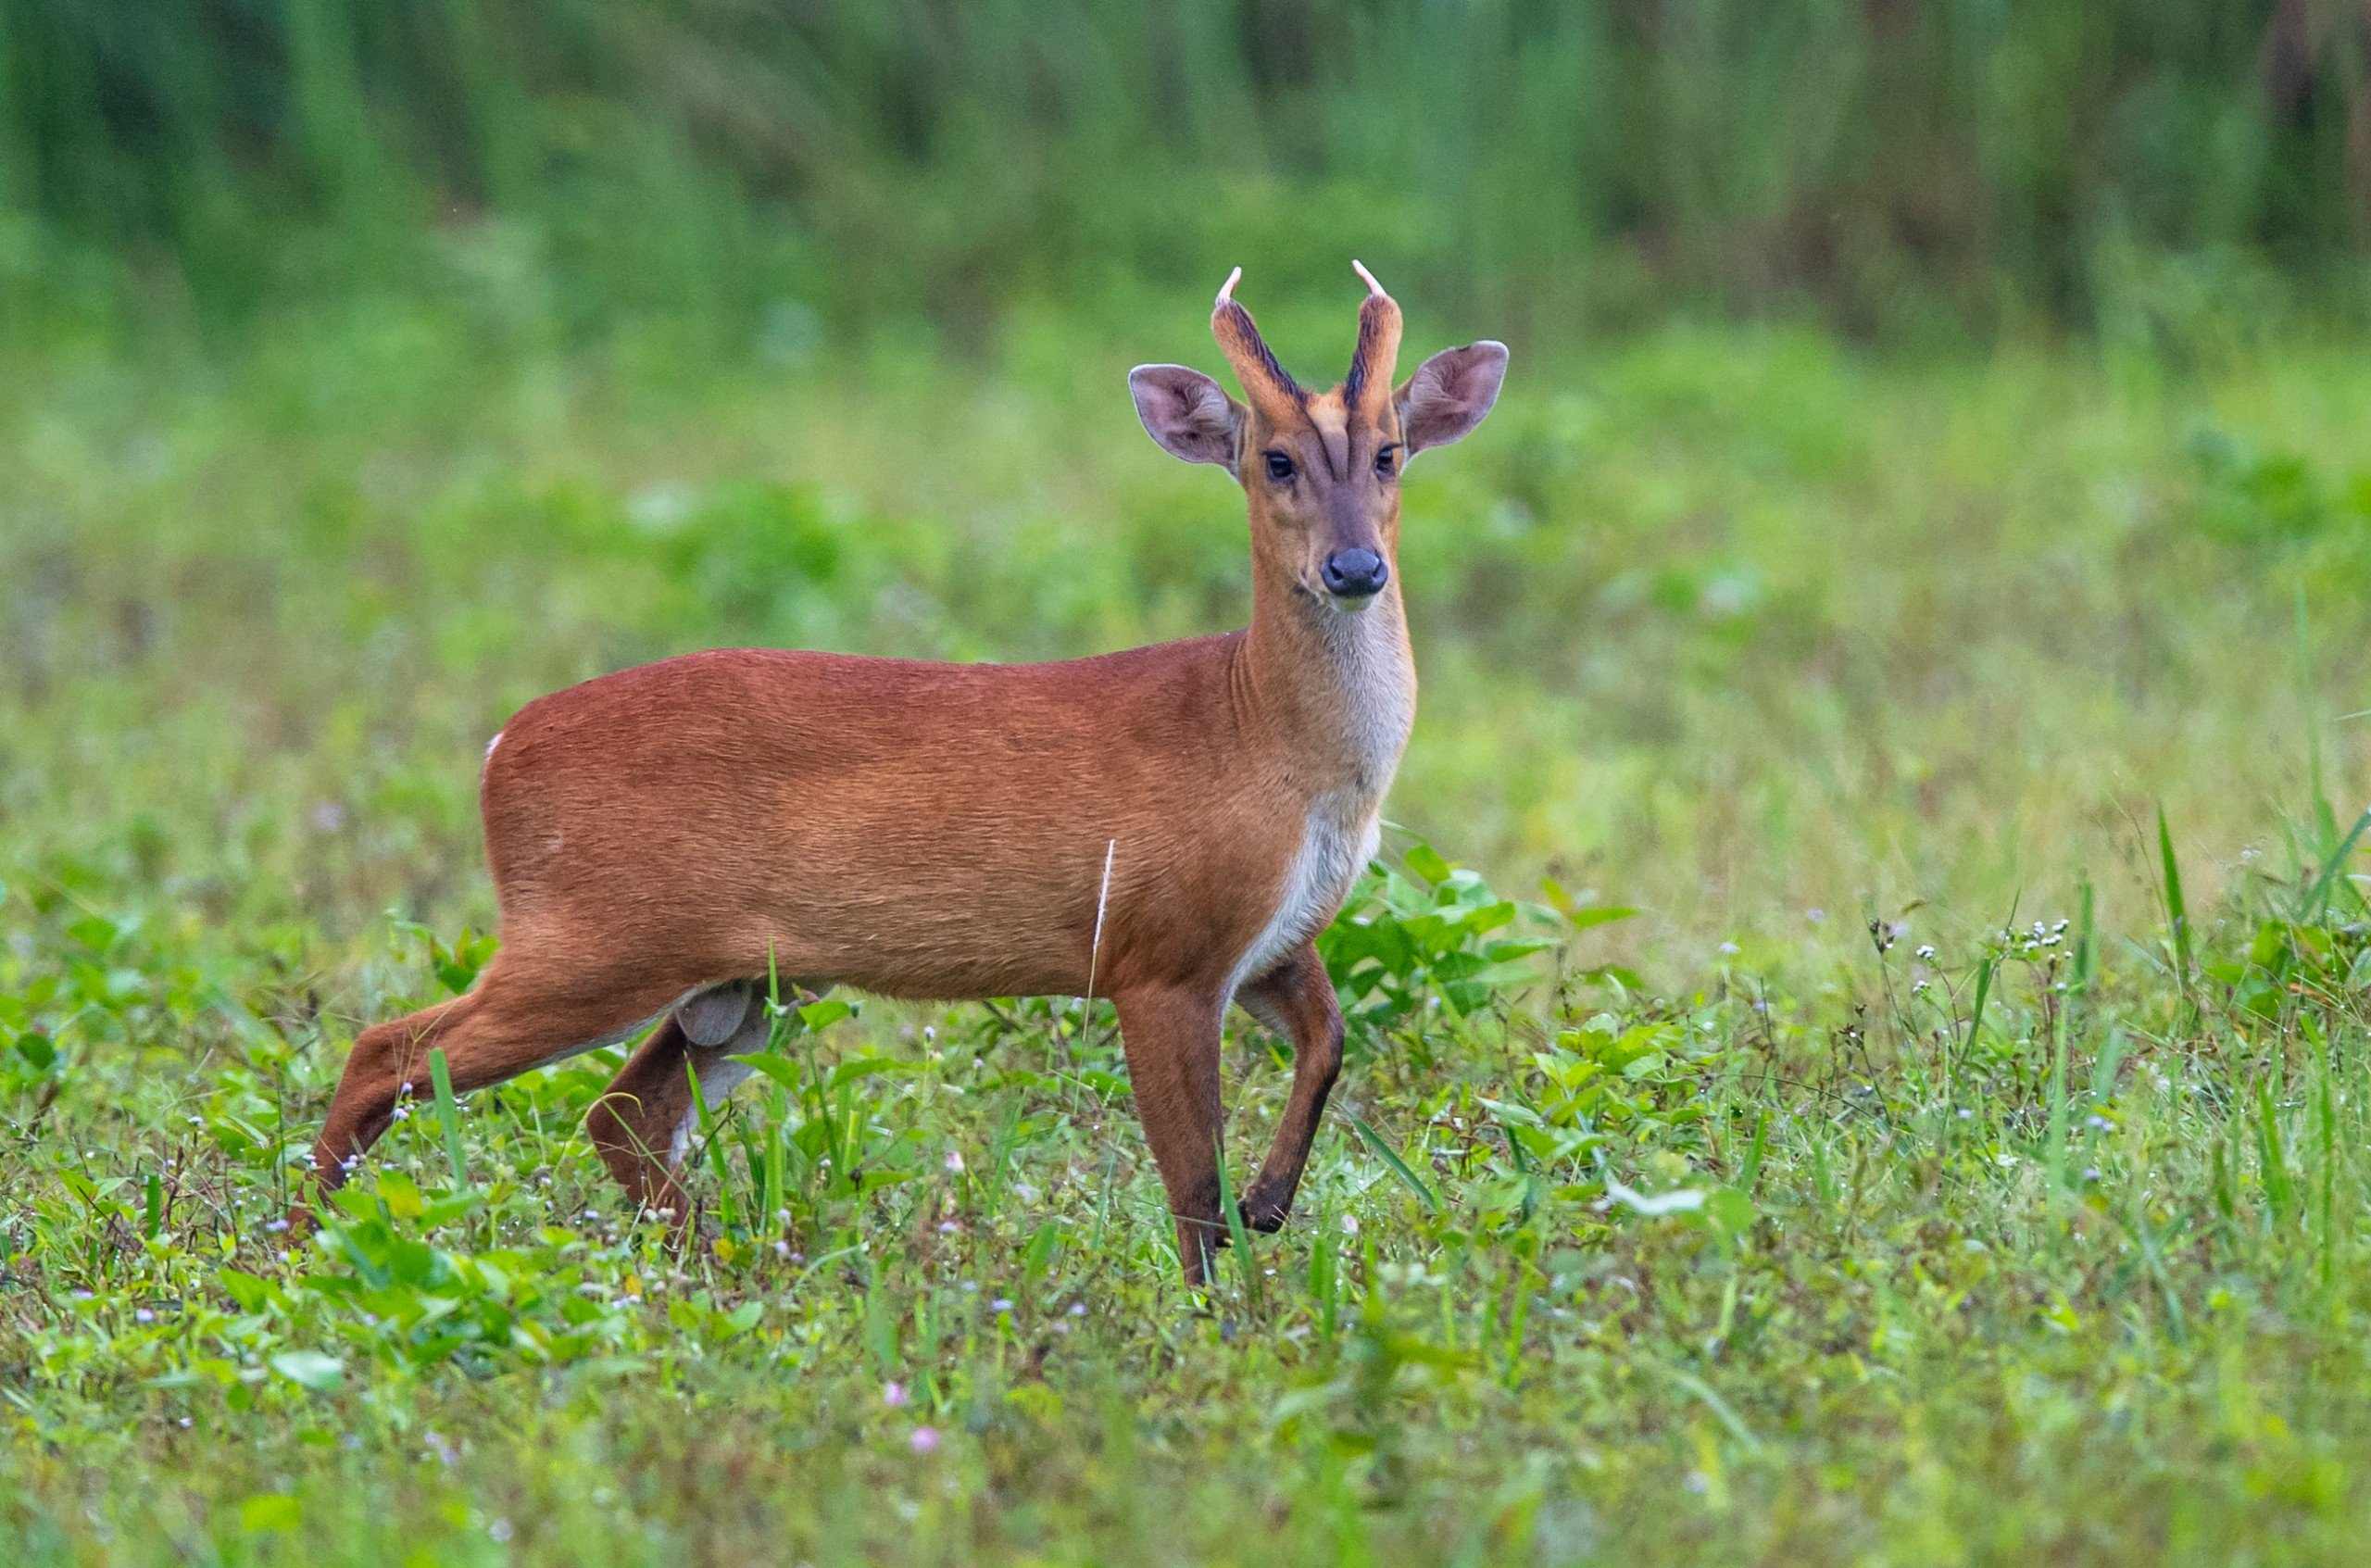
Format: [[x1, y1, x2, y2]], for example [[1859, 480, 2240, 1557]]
[[1245, 574, 1415, 807]]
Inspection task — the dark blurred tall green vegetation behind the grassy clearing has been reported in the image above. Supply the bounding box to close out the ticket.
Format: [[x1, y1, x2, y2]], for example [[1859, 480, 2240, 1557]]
[[14, 0, 2371, 341]]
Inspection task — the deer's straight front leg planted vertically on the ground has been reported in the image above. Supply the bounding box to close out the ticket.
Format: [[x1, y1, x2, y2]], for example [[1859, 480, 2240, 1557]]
[[1112, 986, 1226, 1288]]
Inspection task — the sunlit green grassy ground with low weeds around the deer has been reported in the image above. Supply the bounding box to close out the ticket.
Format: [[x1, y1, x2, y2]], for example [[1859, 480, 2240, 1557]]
[[14, 301, 2371, 1563]]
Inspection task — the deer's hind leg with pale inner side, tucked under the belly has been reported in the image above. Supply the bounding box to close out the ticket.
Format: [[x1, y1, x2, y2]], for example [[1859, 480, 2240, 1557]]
[[585, 986, 773, 1234]]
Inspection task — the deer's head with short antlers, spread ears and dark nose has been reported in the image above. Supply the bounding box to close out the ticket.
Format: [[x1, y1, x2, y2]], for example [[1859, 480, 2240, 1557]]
[[1129, 261, 1506, 609]]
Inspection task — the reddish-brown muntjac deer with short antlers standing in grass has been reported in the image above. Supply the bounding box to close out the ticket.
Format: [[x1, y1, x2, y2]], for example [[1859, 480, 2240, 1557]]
[[313, 263, 1506, 1284]]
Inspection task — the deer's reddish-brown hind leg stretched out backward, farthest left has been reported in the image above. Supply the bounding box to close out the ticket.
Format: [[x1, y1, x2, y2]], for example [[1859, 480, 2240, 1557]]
[[313, 954, 681, 1191]]
